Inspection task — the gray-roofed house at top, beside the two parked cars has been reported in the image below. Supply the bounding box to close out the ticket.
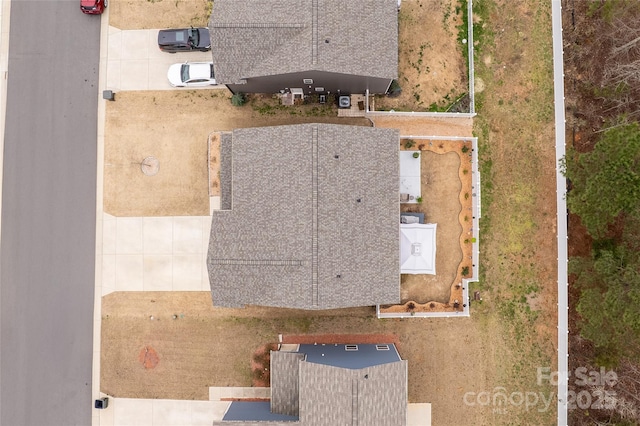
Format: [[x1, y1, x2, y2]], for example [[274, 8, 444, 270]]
[[209, 0, 398, 97]]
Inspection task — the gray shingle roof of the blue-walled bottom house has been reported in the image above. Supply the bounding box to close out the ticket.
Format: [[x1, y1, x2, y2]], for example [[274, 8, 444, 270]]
[[214, 344, 408, 426]]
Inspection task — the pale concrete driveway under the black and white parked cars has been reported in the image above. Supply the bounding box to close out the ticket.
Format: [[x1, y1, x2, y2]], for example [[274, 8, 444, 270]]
[[106, 26, 226, 91]]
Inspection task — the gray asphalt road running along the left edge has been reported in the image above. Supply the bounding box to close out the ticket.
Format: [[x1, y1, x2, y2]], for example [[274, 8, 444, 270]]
[[0, 0, 100, 426]]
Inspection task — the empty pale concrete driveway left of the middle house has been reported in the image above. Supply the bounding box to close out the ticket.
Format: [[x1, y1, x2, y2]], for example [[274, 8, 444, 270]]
[[102, 213, 211, 296]]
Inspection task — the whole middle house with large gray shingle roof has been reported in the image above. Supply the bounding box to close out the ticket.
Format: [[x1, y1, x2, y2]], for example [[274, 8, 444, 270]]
[[207, 124, 400, 309]]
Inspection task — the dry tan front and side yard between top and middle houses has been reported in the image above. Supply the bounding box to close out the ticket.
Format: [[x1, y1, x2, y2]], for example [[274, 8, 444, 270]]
[[104, 89, 371, 216]]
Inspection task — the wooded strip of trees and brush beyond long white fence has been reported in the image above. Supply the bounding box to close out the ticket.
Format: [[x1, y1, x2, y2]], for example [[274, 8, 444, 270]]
[[563, 0, 640, 425]]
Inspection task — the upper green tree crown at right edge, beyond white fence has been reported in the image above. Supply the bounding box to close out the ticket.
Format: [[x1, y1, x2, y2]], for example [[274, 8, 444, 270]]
[[565, 123, 640, 238]]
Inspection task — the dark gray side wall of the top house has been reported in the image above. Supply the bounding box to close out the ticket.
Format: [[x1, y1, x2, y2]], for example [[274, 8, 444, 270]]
[[227, 71, 392, 95]]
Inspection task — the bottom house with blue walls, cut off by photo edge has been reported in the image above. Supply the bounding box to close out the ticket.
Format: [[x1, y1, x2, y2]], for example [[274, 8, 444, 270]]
[[213, 344, 407, 426]]
